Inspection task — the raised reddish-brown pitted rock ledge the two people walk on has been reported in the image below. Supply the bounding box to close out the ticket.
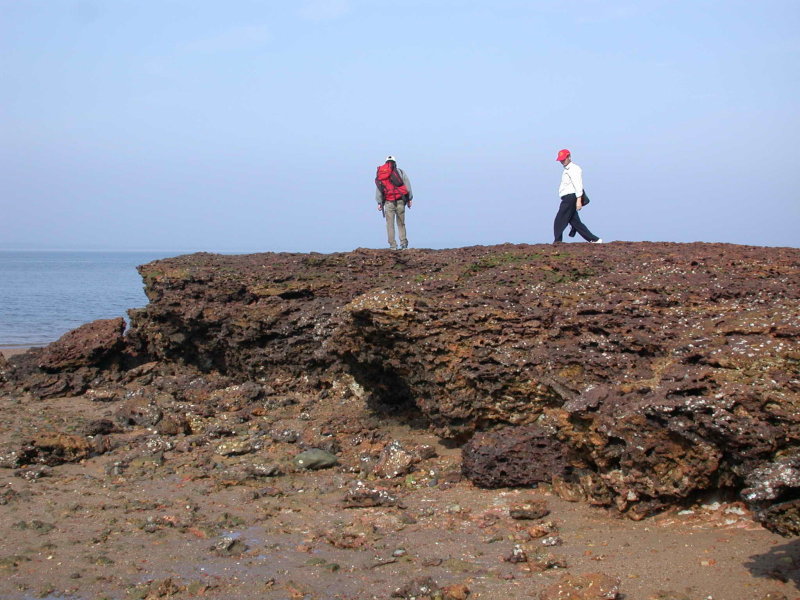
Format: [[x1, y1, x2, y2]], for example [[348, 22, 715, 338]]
[[0, 243, 800, 535]]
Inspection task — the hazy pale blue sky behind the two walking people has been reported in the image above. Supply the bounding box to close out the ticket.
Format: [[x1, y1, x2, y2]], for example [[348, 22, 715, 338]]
[[0, 0, 800, 252]]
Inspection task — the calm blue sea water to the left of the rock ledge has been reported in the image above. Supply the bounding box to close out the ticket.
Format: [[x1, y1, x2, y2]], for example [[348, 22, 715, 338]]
[[0, 251, 174, 346]]
